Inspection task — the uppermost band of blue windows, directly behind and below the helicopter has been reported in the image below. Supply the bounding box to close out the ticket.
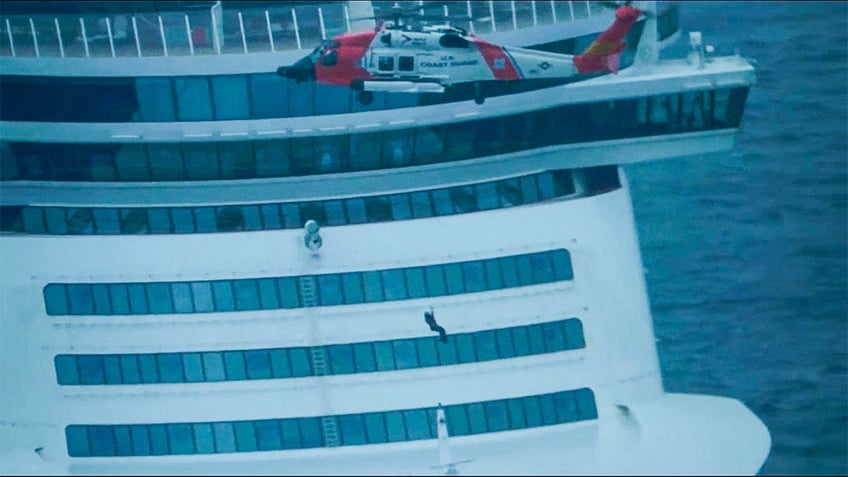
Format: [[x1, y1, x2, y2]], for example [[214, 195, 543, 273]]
[[0, 27, 608, 123]]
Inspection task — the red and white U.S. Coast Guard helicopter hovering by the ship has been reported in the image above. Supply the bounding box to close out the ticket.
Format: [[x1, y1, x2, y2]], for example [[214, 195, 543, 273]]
[[277, 2, 645, 104]]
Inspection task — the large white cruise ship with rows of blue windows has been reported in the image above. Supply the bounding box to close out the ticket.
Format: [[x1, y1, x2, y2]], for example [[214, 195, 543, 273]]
[[0, 0, 771, 475]]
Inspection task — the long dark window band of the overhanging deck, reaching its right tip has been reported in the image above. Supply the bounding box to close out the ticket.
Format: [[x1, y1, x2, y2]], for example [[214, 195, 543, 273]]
[[0, 88, 747, 181]]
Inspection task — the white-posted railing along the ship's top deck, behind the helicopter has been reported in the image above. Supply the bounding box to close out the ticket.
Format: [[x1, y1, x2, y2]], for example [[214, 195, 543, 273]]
[[0, 1, 609, 58]]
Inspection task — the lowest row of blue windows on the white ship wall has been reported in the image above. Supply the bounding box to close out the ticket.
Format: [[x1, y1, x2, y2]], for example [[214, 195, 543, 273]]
[[65, 388, 598, 457]]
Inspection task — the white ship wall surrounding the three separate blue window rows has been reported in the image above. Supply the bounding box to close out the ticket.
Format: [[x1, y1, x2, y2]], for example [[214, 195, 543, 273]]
[[0, 172, 768, 473]]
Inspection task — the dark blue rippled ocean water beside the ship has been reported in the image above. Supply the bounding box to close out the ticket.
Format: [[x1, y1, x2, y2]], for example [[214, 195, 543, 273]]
[[625, 2, 848, 475]]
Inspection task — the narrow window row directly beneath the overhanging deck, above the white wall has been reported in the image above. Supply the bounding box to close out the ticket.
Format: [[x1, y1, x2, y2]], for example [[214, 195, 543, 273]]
[[0, 166, 608, 235]]
